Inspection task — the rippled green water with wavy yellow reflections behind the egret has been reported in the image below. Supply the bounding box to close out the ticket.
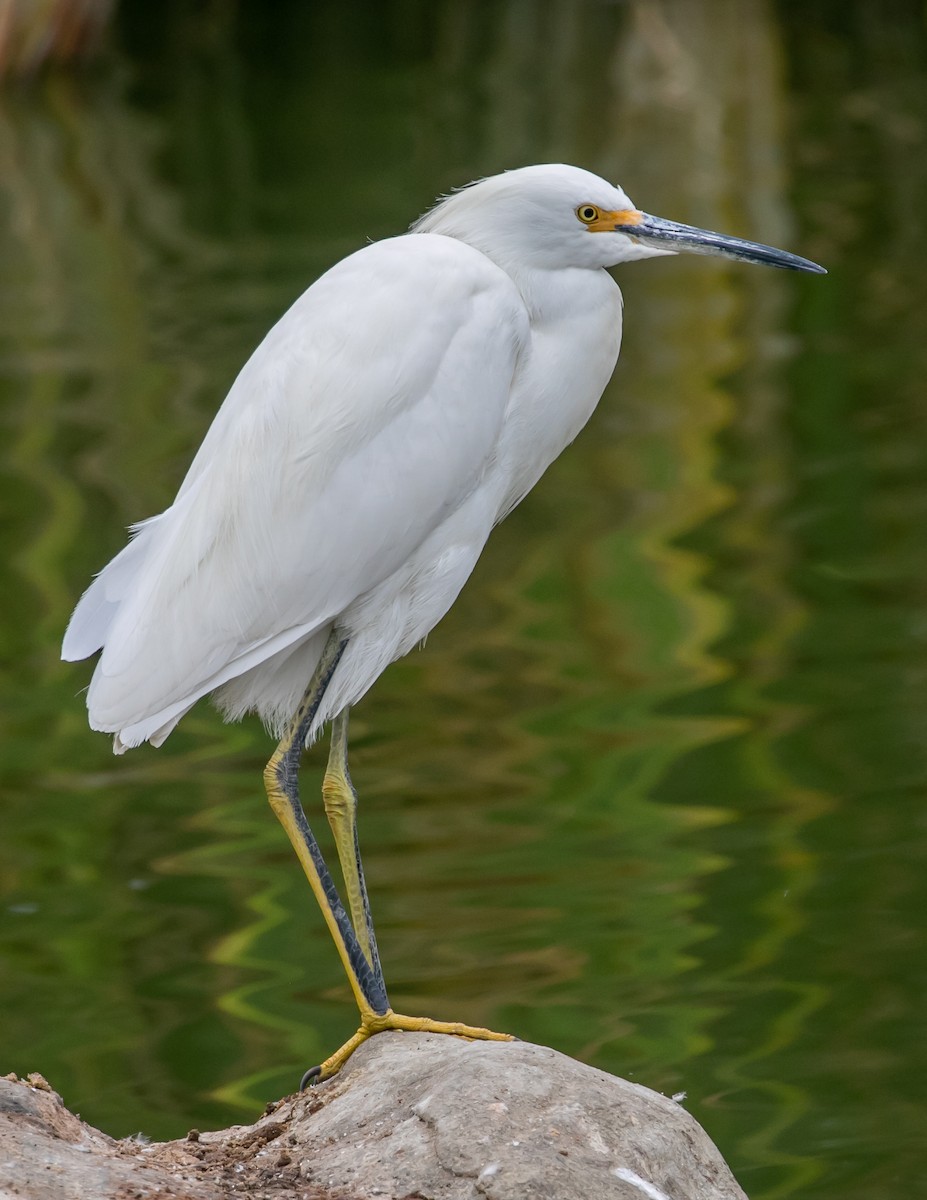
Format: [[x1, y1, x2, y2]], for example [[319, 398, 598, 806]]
[[0, 0, 927, 1200]]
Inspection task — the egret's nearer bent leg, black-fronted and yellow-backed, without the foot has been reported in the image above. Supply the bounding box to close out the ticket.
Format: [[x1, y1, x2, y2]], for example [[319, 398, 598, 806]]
[[264, 632, 389, 1016]]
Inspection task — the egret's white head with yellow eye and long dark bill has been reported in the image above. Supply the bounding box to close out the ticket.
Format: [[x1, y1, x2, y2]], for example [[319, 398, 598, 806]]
[[412, 163, 824, 274]]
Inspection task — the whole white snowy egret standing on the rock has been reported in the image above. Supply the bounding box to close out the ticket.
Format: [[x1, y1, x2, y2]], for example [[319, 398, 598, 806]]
[[62, 166, 823, 1078]]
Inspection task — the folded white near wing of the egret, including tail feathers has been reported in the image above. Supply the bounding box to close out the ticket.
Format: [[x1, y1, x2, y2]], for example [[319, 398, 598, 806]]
[[65, 235, 528, 731]]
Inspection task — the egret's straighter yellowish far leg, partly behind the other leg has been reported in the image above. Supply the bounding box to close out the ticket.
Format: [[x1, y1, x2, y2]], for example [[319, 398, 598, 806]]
[[322, 708, 387, 996]]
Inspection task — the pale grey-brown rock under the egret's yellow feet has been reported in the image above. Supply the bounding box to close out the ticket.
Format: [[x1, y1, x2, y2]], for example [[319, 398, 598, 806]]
[[0, 1033, 746, 1200]]
